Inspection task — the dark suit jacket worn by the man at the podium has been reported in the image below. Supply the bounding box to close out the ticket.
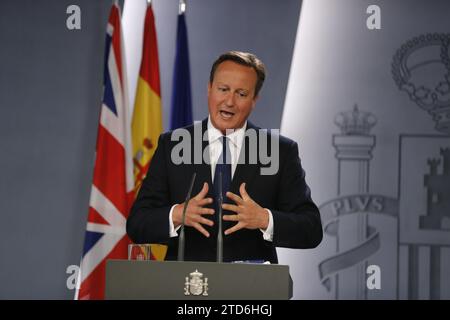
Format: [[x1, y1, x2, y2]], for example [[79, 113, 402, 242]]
[[127, 119, 322, 263]]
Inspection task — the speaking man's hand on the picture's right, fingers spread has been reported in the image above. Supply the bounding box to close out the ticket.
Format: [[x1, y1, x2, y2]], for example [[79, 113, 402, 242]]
[[222, 183, 269, 235]]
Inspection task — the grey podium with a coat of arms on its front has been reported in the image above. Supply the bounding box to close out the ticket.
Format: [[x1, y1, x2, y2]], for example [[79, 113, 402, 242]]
[[105, 260, 292, 300]]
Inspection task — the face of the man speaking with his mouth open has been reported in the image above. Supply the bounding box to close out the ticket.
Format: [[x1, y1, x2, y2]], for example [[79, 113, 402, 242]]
[[208, 61, 257, 133]]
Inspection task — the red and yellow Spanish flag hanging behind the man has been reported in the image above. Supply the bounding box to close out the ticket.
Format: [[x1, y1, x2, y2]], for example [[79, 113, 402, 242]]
[[131, 4, 162, 194]]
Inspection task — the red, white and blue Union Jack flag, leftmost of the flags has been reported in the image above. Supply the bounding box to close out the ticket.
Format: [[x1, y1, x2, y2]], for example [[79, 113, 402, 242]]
[[75, 2, 134, 299]]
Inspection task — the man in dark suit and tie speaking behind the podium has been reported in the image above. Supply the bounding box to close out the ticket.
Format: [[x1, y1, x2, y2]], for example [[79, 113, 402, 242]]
[[127, 51, 322, 263]]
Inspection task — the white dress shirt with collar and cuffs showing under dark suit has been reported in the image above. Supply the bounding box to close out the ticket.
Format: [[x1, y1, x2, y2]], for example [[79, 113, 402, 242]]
[[169, 117, 273, 241]]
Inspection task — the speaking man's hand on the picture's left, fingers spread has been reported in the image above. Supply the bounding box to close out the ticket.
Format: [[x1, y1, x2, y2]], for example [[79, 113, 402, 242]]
[[172, 182, 214, 237]]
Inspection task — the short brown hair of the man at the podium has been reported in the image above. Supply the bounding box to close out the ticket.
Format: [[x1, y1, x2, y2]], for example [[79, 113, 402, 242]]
[[209, 51, 266, 97]]
